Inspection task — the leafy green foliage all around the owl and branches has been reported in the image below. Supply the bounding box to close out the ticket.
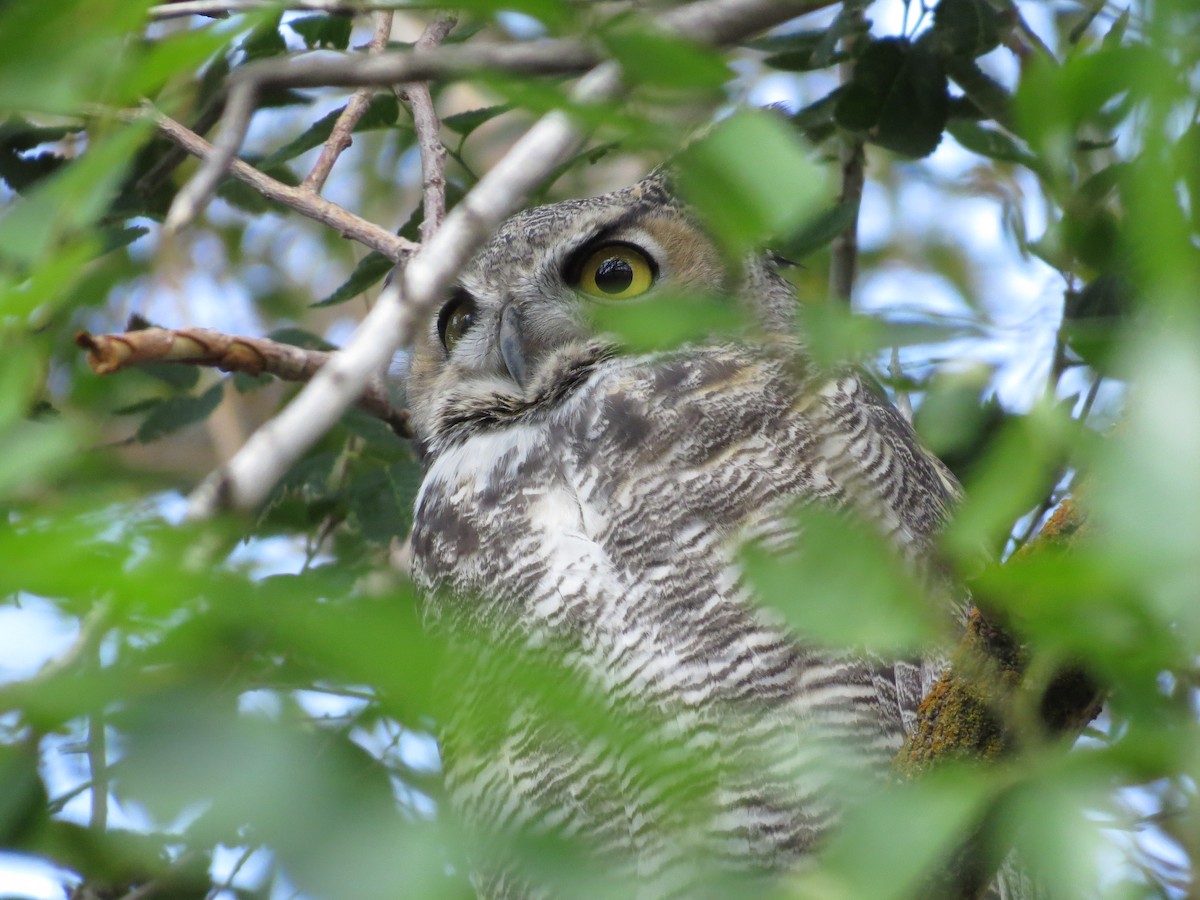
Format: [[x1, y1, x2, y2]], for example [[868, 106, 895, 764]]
[[0, 0, 1200, 900]]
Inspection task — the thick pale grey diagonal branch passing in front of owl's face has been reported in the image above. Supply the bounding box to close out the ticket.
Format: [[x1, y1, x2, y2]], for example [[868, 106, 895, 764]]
[[188, 0, 829, 518]]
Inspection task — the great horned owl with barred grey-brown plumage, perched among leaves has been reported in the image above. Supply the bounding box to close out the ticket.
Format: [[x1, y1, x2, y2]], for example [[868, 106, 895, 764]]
[[408, 173, 956, 896]]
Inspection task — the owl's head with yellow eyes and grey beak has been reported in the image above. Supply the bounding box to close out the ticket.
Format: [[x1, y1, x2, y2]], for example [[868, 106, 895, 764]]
[[407, 169, 796, 442]]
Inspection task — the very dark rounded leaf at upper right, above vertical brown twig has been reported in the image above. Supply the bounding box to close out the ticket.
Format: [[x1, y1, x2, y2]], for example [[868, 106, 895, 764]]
[[835, 37, 949, 157]]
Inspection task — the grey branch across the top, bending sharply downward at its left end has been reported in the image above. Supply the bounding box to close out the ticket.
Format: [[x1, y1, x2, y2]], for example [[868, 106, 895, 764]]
[[163, 0, 840, 232]]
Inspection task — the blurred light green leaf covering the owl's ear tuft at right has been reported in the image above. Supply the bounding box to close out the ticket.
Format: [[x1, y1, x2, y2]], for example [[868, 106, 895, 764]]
[[673, 110, 827, 254]]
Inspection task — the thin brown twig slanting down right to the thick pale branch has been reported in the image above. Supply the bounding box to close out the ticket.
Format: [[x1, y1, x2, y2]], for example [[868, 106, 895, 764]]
[[144, 106, 416, 260]]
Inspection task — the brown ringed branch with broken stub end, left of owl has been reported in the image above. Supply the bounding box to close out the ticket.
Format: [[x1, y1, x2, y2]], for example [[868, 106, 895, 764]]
[[76, 328, 413, 438]]
